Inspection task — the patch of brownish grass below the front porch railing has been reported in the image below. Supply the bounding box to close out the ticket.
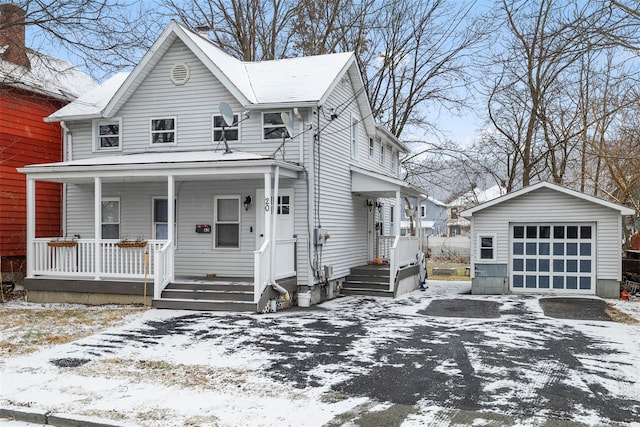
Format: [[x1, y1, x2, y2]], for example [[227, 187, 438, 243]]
[[0, 306, 143, 357]]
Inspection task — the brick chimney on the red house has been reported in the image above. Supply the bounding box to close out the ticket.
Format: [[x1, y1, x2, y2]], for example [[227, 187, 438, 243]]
[[0, 3, 31, 68]]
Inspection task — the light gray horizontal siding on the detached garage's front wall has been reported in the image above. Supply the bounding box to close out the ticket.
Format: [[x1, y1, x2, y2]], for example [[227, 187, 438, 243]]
[[471, 187, 622, 280]]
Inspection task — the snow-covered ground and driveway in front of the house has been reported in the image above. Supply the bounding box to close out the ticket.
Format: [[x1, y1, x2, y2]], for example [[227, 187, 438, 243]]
[[0, 282, 640, 426]]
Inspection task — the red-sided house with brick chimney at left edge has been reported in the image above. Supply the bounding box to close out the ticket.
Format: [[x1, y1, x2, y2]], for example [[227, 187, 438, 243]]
[[0, 3, 95, 281]]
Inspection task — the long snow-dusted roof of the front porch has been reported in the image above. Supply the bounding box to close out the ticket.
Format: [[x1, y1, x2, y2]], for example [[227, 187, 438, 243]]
[[18, 151, 303, 183]]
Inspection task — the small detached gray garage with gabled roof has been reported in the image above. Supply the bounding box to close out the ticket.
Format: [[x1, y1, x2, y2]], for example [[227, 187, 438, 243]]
[[461, 182, 635, 298]]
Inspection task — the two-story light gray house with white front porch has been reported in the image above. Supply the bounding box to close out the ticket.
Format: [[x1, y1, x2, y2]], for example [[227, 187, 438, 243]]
[[21, 22, 420, 312]]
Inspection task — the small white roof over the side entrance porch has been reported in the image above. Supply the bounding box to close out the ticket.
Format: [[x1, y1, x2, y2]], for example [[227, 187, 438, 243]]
[[351, 166, 427, 201]]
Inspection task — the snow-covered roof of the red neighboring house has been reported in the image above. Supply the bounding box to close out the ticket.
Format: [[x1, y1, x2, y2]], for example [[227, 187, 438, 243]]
[[0, 50, 97, 101]]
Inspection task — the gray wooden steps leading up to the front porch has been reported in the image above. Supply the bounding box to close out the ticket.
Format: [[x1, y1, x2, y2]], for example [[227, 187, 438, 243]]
[[153, 282, 256, 312]]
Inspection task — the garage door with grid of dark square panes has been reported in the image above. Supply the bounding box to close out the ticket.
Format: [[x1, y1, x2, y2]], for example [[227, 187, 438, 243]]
[[510, 223, 596, 294]]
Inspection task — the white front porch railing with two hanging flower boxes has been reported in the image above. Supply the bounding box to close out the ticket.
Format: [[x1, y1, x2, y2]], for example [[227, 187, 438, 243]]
[[32, 238, 165, 278]]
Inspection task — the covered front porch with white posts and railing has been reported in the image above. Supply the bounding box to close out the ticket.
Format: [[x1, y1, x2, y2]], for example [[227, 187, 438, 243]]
[[21, 152, 301, 309]]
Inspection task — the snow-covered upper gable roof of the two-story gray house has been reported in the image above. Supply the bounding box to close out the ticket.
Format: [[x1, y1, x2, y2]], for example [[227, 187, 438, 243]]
[[49, 21, 375, 134]]
